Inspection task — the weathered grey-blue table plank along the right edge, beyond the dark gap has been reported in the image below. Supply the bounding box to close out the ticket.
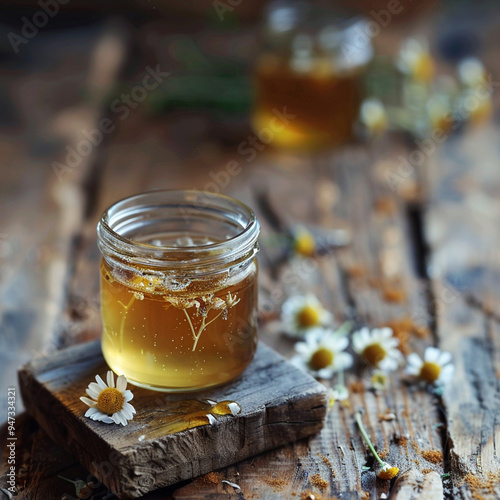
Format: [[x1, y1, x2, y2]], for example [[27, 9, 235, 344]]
[[425, 126, 500, 499]]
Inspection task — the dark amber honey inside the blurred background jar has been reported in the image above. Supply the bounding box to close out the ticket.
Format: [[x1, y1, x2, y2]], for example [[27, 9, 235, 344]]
[[252, 56, 360, 150]]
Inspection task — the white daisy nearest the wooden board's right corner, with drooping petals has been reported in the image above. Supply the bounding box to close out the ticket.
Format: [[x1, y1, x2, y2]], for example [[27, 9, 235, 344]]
[[291, 329, 352, 378]]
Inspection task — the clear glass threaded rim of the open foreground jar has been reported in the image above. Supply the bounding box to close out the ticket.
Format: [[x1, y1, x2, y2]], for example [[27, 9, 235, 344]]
[[97, 189, 260, 274]]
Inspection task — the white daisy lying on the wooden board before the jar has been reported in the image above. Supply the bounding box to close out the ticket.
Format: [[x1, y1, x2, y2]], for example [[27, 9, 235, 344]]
[[80, 370, 135, 425]]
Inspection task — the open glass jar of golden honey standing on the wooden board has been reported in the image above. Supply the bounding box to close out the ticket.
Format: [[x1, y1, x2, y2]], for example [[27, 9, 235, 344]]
[[97, 190, 259, 392]]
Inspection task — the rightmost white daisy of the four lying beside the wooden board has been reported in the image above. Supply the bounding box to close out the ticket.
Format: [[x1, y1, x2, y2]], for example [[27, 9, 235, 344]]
[[406, 347, 455, 386]]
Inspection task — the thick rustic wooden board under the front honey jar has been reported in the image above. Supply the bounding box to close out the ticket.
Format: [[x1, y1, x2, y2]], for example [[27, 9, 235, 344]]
[[19, 341, 327, 498]]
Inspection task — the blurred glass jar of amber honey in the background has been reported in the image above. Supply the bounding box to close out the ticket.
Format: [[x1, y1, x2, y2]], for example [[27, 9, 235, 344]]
[[251, 0, 373, 151]]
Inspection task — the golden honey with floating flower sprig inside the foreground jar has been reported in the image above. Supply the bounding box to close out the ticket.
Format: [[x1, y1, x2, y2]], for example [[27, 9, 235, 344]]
[[100, 191, 258, 391]]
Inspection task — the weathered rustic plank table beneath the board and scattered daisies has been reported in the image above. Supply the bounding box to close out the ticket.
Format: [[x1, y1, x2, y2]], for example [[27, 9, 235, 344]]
[[0, 8, 500, 500]]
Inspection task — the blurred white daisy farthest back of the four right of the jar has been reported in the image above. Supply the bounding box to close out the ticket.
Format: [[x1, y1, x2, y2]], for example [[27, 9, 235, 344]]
[[281, 294, 333, 338]]
